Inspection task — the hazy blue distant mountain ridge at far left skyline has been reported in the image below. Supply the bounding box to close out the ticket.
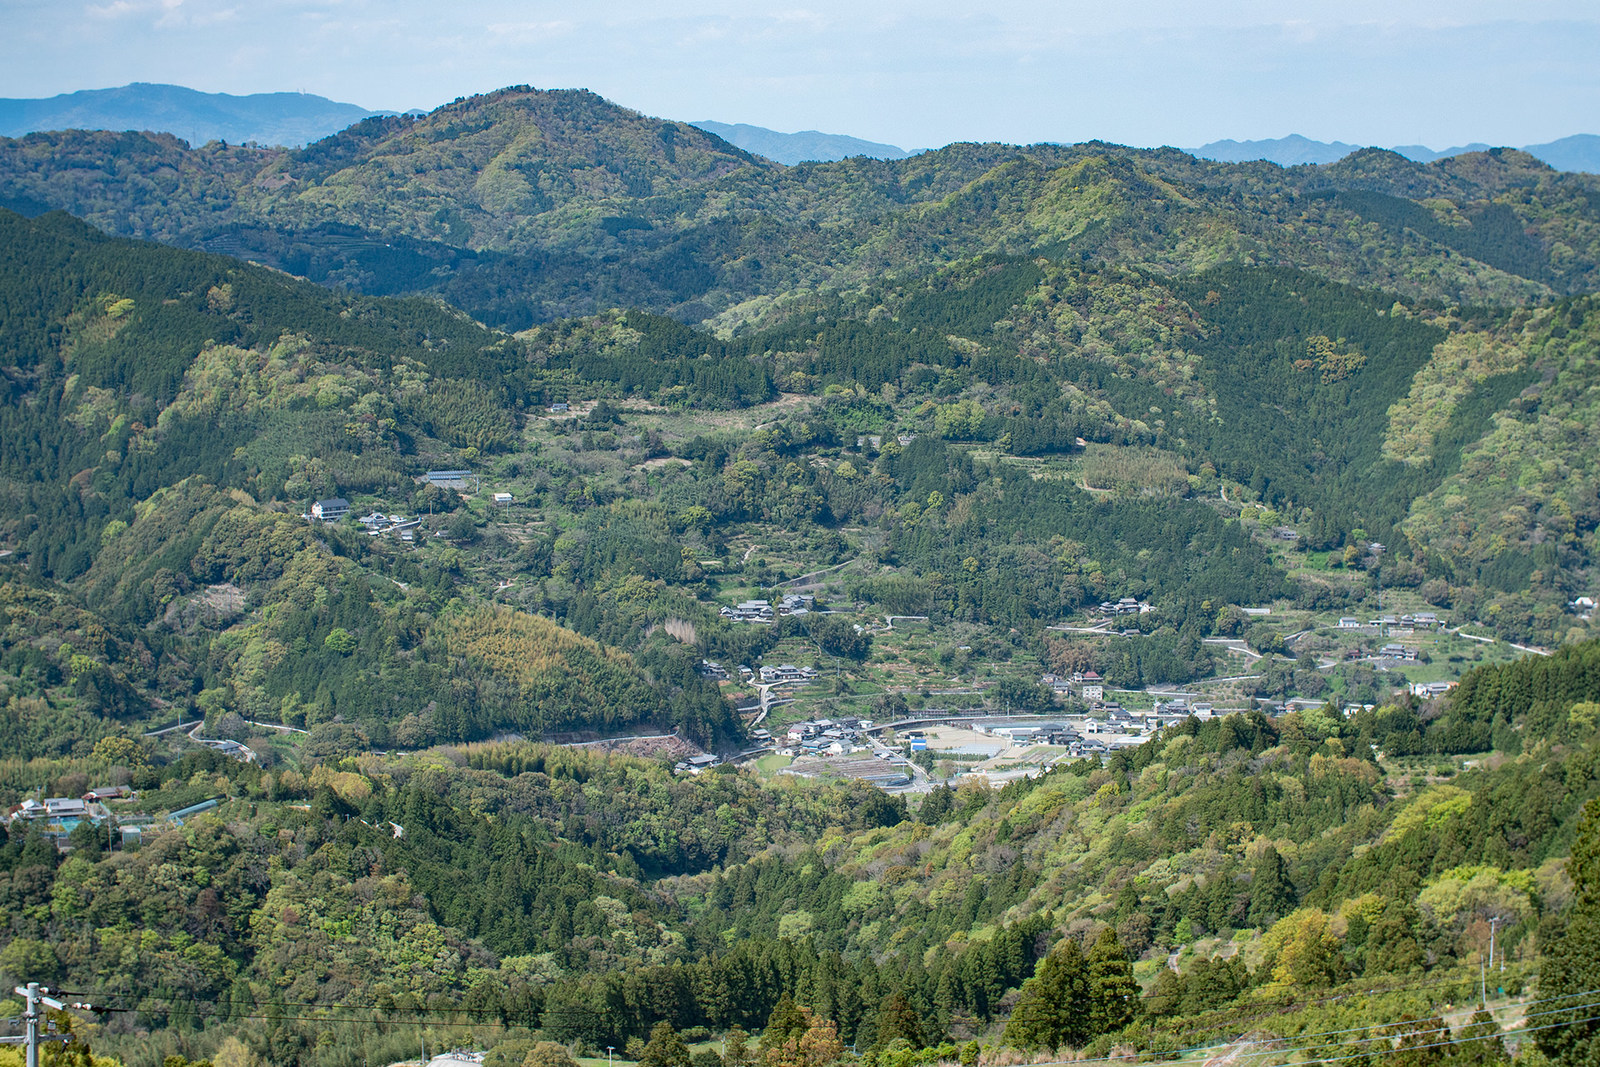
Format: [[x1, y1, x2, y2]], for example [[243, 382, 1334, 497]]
[[0, 82, 385, 147]]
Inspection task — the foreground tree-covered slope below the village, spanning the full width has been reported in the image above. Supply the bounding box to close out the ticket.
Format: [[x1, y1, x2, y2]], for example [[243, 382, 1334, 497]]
[[0, 643, 1600, 1064]]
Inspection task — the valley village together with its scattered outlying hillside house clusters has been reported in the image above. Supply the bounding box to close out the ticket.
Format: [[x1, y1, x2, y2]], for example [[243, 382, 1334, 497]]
[[159, 447, 1594, 792]]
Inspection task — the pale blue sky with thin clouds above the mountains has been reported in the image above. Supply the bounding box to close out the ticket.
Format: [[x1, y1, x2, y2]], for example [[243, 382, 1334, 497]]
[[0, 0, 1600, 149]]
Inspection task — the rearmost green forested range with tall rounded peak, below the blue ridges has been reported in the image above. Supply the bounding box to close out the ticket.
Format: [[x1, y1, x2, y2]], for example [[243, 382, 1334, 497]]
[[0, 88, 1600, 328]]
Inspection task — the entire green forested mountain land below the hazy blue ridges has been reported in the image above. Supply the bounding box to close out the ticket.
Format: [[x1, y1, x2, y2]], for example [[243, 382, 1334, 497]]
[[0, 81, 1600, 1067]]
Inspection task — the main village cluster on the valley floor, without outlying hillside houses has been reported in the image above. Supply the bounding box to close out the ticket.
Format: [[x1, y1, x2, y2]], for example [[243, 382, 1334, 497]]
[[678, 559, 1539, 792]]
